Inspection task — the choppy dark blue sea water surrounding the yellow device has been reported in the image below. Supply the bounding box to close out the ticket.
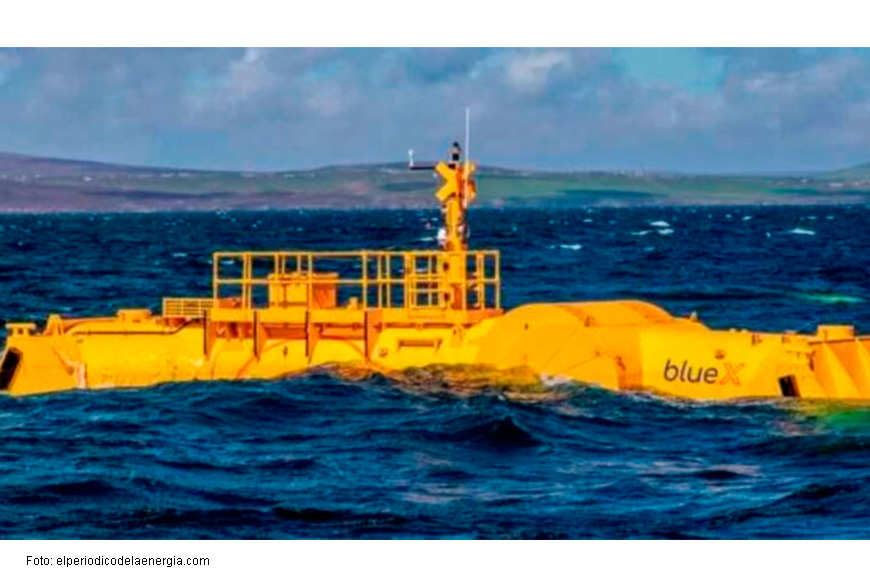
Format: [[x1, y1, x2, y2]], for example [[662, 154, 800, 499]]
[[0, 207, 870, 538]]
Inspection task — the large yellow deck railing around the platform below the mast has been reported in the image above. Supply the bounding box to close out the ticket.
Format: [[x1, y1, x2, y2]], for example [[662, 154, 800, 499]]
[[212, 250, 501, 310]]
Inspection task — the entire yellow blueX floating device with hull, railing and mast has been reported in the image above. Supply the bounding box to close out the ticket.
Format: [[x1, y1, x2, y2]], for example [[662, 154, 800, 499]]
[[0, 144, 870, 399]]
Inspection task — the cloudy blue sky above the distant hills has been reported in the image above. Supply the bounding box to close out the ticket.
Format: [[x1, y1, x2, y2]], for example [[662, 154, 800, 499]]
[[0, 48, 870, 173]]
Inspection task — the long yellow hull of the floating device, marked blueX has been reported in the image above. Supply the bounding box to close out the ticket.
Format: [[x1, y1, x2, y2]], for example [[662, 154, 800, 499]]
[[0, 301, 870, 399]]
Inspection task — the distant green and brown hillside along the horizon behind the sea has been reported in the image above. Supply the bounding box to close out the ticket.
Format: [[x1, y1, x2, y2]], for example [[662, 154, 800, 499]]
[[0, 153, 870, 213]]
